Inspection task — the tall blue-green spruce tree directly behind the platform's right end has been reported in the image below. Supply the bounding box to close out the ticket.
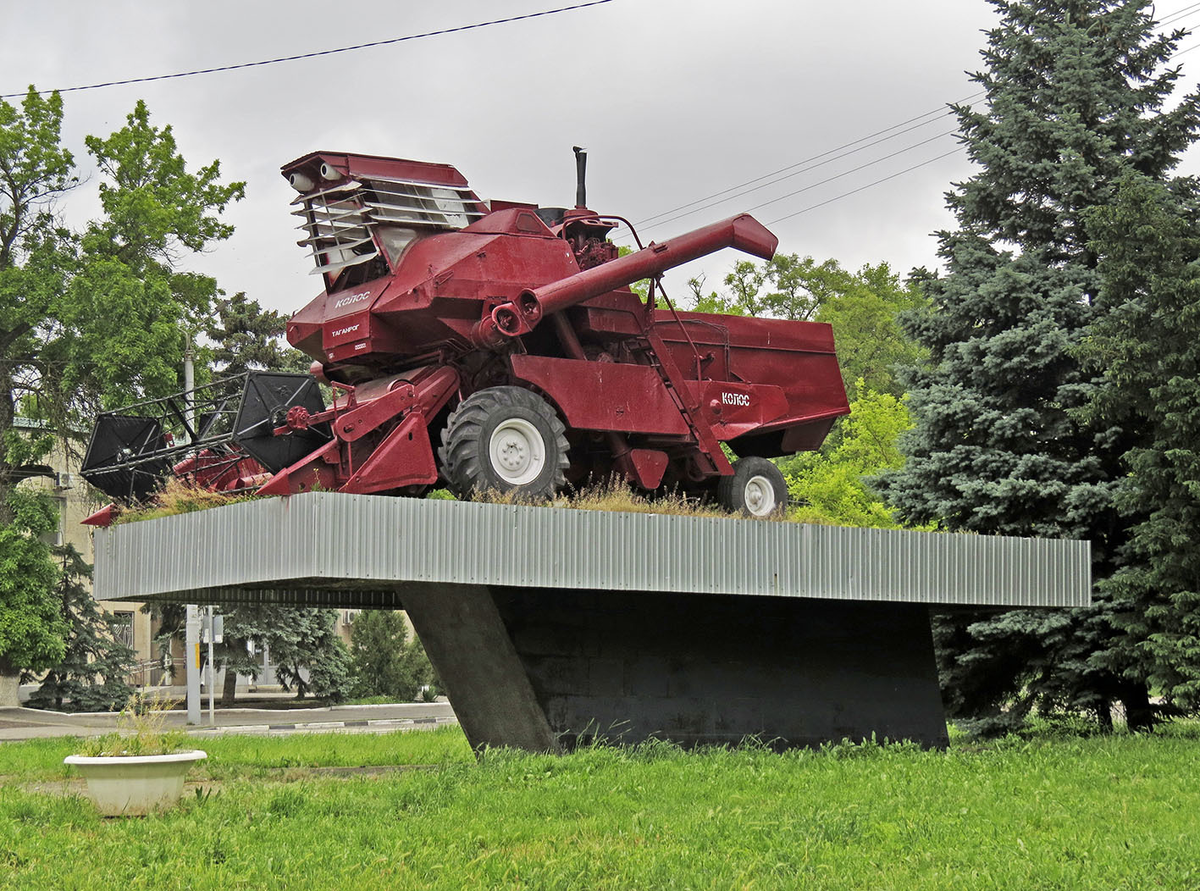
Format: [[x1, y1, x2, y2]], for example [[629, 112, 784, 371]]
[[882, 0, 1200, 729]]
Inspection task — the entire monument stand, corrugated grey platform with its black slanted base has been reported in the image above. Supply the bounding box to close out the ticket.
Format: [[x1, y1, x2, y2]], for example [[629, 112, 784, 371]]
[[95, 492, 1091, 751]]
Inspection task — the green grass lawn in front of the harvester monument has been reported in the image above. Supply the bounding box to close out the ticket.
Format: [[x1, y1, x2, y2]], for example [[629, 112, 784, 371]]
[[0, 726, 1200, 891]]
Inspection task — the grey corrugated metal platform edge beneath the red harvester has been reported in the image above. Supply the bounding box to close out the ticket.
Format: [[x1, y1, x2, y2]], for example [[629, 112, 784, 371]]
[[95, 492, 1091, 606]]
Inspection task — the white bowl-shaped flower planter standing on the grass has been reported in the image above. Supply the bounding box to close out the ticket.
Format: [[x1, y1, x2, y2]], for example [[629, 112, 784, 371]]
[[62, 749, 208, 817]]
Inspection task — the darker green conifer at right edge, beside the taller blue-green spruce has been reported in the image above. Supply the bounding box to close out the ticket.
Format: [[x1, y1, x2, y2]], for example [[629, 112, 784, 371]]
[[1079, 175, 1200, 708]]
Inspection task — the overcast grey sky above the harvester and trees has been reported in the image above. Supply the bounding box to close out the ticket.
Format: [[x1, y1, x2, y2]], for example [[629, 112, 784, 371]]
[[0, 0, 1200, 312]]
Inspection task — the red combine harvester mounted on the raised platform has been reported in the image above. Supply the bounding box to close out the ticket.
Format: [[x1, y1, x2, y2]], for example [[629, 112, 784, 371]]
[[83, 150, 850, 522]]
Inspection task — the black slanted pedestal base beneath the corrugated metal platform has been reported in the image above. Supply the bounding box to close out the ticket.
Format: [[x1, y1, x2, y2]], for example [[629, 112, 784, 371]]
[[403, 586, 947, 751]]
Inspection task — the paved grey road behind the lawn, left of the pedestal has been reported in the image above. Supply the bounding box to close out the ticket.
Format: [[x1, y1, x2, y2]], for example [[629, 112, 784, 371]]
[[0, 701, 457, 741]]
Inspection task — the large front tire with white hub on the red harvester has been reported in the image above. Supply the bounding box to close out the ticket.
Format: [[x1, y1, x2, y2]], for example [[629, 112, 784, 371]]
[[438, 387, 568, 501]]
